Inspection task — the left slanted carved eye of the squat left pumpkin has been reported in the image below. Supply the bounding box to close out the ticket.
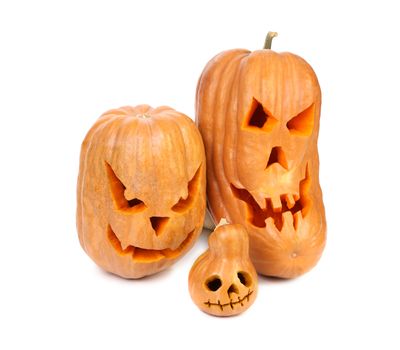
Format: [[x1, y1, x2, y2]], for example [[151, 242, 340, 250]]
[[105, 162, 147, 213]]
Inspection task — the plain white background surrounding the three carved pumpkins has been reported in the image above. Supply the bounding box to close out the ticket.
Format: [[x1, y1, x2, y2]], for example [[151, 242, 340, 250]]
[[0, 0, 400, 350]]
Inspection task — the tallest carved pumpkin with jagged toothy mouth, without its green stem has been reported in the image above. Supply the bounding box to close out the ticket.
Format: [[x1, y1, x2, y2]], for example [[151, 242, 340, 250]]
[[196, 49, 326, 278]]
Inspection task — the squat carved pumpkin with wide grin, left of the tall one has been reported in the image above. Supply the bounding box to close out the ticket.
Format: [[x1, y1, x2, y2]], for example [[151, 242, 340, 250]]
[[77, 105, 206, 278]]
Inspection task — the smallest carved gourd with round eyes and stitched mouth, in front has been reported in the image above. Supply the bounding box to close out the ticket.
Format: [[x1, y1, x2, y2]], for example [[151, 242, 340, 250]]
[[189, 220, 258, 316]]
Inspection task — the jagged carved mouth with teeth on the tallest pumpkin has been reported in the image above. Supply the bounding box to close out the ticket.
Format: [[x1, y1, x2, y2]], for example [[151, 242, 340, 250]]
[[231, 165, 312, 231]]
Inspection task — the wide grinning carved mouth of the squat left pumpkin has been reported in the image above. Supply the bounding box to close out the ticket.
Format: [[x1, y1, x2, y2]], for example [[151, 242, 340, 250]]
[[107, 225, 196, 263]]
